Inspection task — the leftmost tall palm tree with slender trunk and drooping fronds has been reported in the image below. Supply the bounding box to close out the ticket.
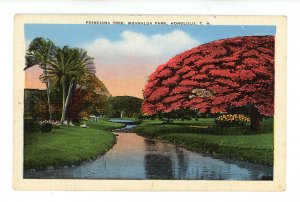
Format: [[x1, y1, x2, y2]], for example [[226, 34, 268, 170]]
[[24, 37, 56, 120]]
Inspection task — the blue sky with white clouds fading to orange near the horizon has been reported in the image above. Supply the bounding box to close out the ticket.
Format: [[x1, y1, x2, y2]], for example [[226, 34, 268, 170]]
[[24, 24, 276, 98]]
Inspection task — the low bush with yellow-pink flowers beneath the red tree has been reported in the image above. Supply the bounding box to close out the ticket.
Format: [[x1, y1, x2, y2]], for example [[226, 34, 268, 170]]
[[215, 114, 250, 127]]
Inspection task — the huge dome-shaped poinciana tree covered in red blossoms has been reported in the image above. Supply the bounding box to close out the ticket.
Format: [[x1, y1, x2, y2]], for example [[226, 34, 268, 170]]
[[142, 36, 274, 129]]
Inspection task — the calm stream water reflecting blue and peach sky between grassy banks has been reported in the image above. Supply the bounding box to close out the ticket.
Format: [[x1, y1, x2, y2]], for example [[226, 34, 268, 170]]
[[24, 133, 273, 180]]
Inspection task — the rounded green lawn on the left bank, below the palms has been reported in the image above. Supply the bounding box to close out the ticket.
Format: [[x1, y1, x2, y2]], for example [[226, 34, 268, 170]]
[[24, 120, 124, 169]]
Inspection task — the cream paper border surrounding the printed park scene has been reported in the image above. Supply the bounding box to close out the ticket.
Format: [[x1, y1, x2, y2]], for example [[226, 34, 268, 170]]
[[13, 15, 287, 191]]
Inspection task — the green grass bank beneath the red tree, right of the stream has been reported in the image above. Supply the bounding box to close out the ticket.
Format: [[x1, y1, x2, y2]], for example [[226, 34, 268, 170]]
[[135, 119, 274, 165]]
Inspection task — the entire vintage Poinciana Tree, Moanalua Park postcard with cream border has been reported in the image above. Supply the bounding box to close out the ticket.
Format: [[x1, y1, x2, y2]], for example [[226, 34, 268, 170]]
[[13, 15, 287, 191]]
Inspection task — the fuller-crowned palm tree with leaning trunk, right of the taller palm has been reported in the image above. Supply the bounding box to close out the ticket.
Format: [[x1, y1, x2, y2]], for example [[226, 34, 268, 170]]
[[44, 46, 95, 124]]
